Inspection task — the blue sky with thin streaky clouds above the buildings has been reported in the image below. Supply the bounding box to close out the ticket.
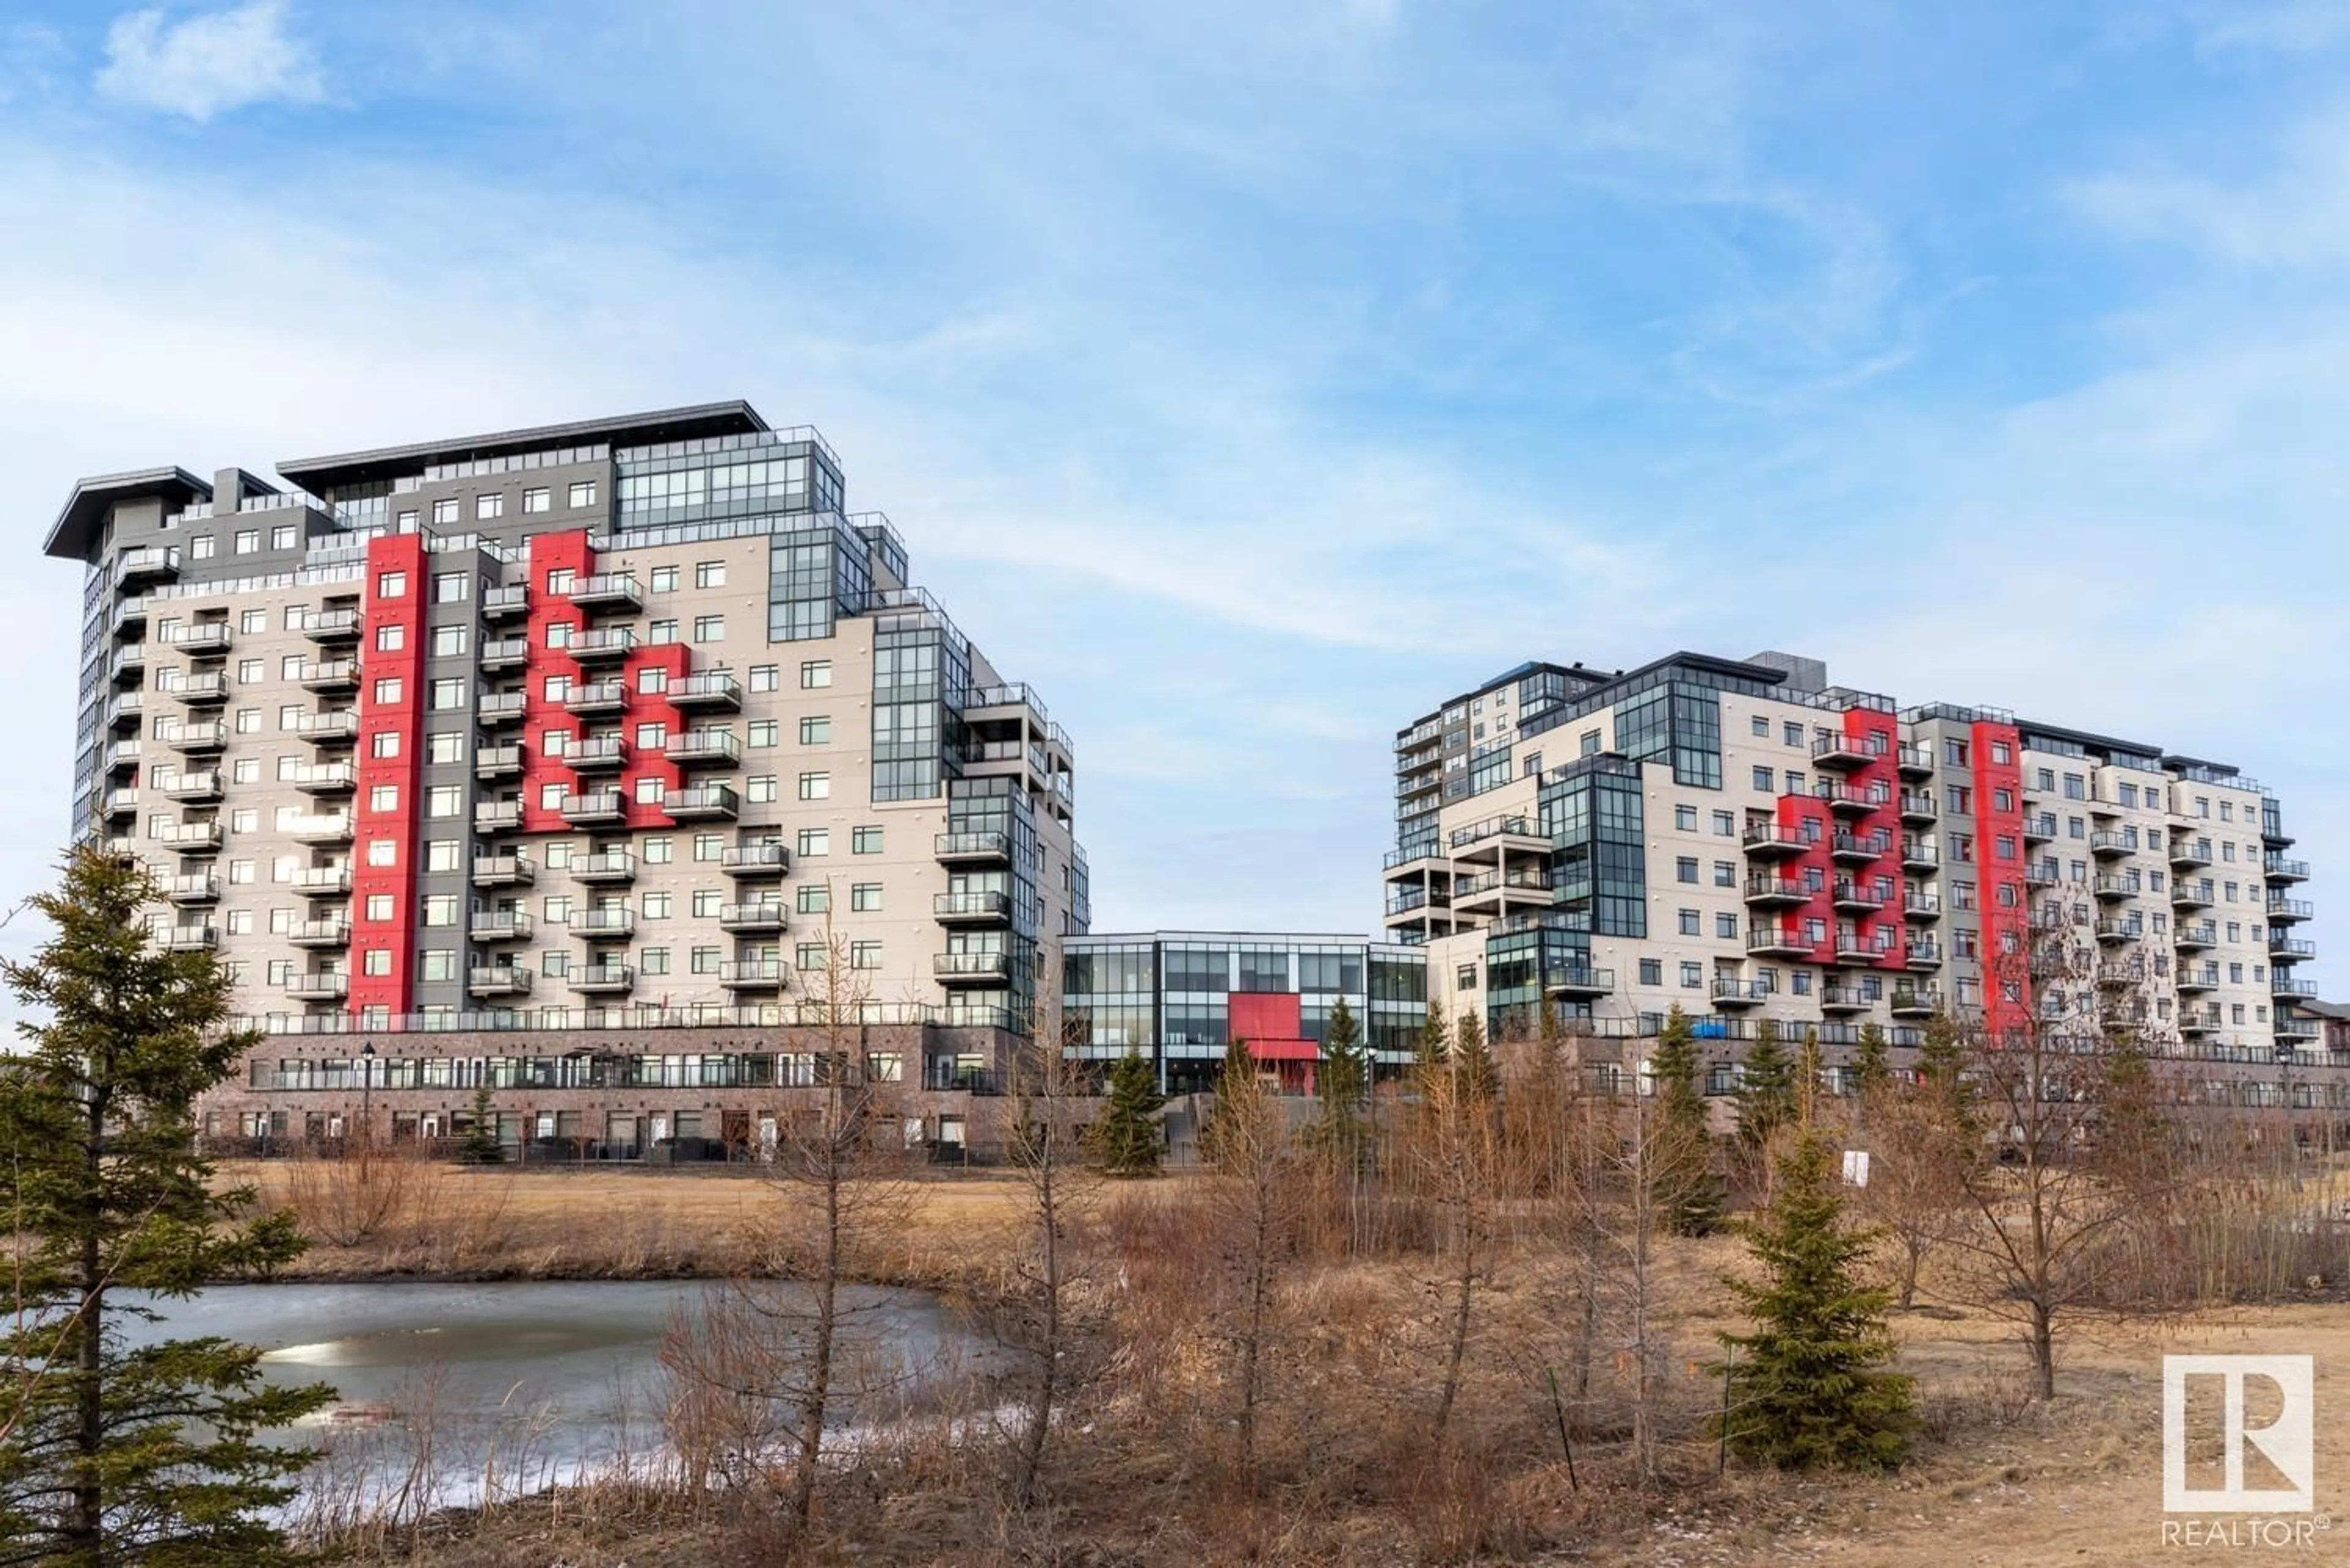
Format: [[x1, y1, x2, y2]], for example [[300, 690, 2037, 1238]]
[[0, 0, 2350, 973]]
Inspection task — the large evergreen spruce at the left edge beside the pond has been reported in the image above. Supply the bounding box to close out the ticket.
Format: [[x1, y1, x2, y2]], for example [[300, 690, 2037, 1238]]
[[0, 846, 334, 1568]]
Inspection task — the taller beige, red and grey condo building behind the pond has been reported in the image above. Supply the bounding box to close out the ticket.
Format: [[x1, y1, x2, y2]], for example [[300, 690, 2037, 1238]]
[[47, 402, 1086, 1143]]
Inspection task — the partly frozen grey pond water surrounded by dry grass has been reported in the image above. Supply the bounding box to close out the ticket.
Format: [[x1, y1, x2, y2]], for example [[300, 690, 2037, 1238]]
[[122, 1281, 968, 1504]]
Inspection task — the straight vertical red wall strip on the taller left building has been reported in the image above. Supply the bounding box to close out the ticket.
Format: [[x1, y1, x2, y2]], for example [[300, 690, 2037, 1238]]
[[350, 534, 428, 1014]]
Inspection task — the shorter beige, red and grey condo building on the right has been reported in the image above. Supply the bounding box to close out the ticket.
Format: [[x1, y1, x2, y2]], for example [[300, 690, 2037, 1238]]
[[1384, 654, 2322, 1100]]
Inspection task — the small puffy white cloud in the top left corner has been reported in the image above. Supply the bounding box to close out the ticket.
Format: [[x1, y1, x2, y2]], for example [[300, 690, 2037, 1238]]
[[96, 0, 327, 122]]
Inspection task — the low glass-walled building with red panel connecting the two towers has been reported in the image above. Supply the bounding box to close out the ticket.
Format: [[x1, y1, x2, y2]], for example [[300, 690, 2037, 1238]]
[[1062, 931, 1429, 1093]]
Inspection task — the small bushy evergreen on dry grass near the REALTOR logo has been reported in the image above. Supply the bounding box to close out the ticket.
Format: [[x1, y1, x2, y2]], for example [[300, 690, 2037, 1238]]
[[1713, 1126, 1917, 1469]]
